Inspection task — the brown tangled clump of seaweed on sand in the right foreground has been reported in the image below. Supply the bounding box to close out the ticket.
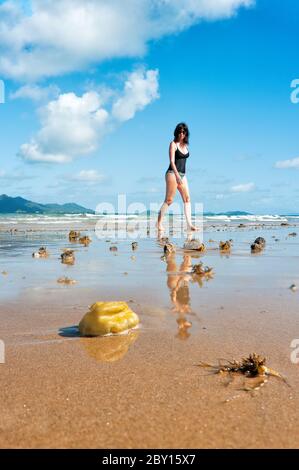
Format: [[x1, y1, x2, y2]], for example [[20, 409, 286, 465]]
[[198, 353, 288, 392]]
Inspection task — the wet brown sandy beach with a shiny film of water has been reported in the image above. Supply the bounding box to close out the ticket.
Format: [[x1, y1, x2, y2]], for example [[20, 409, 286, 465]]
[[0, 222, 299, 449]]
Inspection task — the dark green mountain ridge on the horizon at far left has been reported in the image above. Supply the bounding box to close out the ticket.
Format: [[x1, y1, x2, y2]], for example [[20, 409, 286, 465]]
[[0, 194, 95, 214]]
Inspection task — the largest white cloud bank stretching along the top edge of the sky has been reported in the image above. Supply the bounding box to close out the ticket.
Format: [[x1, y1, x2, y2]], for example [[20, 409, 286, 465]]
[[0, 0, 255, 80]]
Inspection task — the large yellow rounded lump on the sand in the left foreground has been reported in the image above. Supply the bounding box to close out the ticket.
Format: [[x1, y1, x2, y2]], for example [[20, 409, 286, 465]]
[[79, 302, 139, 336]]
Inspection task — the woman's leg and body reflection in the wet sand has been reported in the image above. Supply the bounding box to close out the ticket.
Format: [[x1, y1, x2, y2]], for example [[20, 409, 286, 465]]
[[165, 253, 192, 339]]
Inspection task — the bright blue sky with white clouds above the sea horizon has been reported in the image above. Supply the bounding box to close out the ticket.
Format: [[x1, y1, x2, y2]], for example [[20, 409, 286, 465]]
[[0, 0, 299, 213]]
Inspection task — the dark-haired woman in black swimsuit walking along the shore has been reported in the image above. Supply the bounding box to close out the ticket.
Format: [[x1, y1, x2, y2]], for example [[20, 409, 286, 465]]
[[158, 122, 196, 231]]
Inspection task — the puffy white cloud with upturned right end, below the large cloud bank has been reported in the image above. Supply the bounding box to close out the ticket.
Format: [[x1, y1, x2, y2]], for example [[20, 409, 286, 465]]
[[19, 70, 158, 163]]
